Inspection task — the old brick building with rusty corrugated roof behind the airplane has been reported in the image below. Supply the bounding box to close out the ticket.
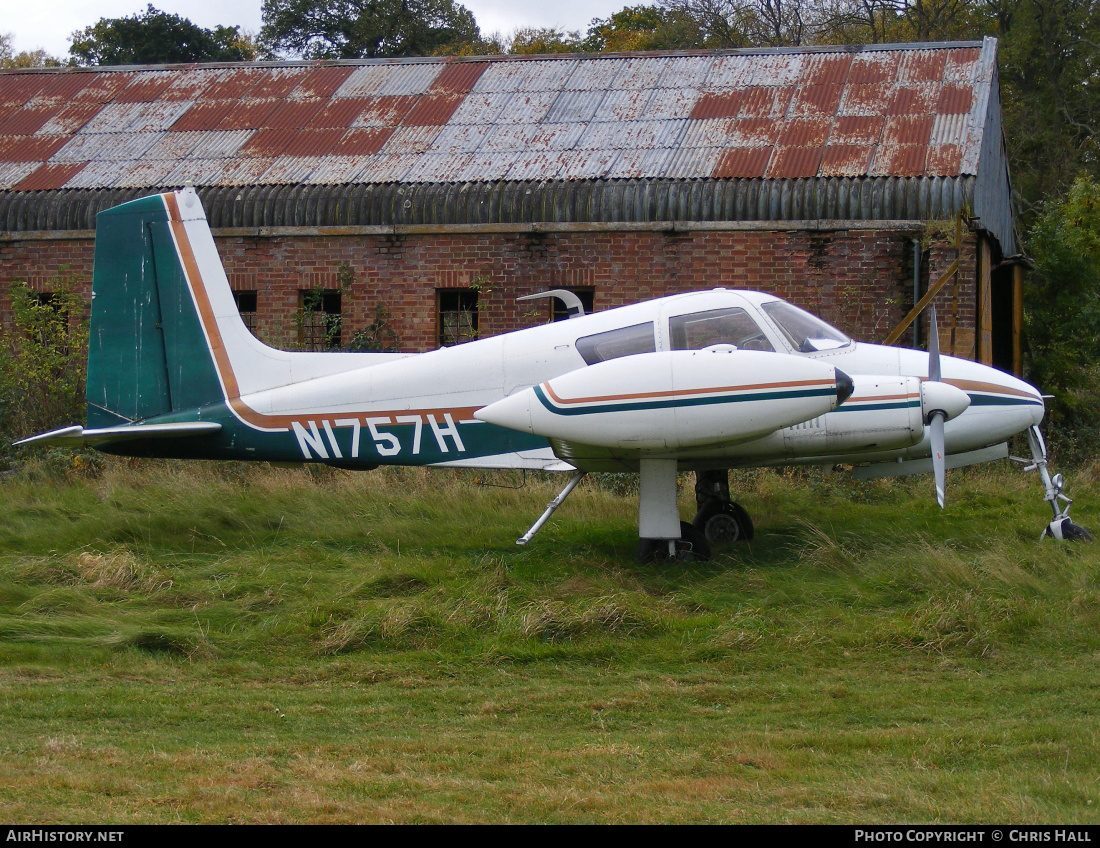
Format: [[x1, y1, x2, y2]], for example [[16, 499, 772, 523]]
[[0, 40, 1022, 371]]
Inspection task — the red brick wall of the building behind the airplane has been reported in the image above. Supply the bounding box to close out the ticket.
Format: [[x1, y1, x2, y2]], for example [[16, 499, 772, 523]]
[[0, 229, 975, 355]]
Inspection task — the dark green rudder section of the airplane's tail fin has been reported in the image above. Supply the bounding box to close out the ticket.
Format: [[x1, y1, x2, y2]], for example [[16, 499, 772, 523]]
[[87, 196, 224, 427]]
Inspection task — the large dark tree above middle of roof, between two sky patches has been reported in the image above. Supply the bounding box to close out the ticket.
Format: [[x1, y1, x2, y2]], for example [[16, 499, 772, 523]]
[[260, 0, 481, 59]]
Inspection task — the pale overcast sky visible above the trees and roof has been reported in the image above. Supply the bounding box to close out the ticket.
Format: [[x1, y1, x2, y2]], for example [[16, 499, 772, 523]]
[[0, 0, 640, 58]]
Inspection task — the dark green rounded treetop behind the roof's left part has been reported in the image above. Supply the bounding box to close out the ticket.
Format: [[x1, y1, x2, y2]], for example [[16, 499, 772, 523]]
[[69, 4, 256, 65]]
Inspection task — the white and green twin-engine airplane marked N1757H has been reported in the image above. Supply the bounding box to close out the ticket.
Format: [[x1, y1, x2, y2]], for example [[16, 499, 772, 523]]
[[18, 188, 1089, 561]]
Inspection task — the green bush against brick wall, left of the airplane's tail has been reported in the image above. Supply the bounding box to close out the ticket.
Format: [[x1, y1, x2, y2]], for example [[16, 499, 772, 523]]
[[0, 279, 88, 450]]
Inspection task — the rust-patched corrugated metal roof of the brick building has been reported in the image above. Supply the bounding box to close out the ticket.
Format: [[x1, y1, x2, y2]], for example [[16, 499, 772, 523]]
[[0, 40, 1011, 250]]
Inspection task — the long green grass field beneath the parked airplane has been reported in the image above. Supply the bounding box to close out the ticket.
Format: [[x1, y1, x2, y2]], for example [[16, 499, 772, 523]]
[[0, 460, 1100, 824]]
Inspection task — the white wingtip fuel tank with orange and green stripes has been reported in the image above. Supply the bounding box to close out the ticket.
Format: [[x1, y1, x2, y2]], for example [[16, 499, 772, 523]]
[[474, 346, 851, 451]]
